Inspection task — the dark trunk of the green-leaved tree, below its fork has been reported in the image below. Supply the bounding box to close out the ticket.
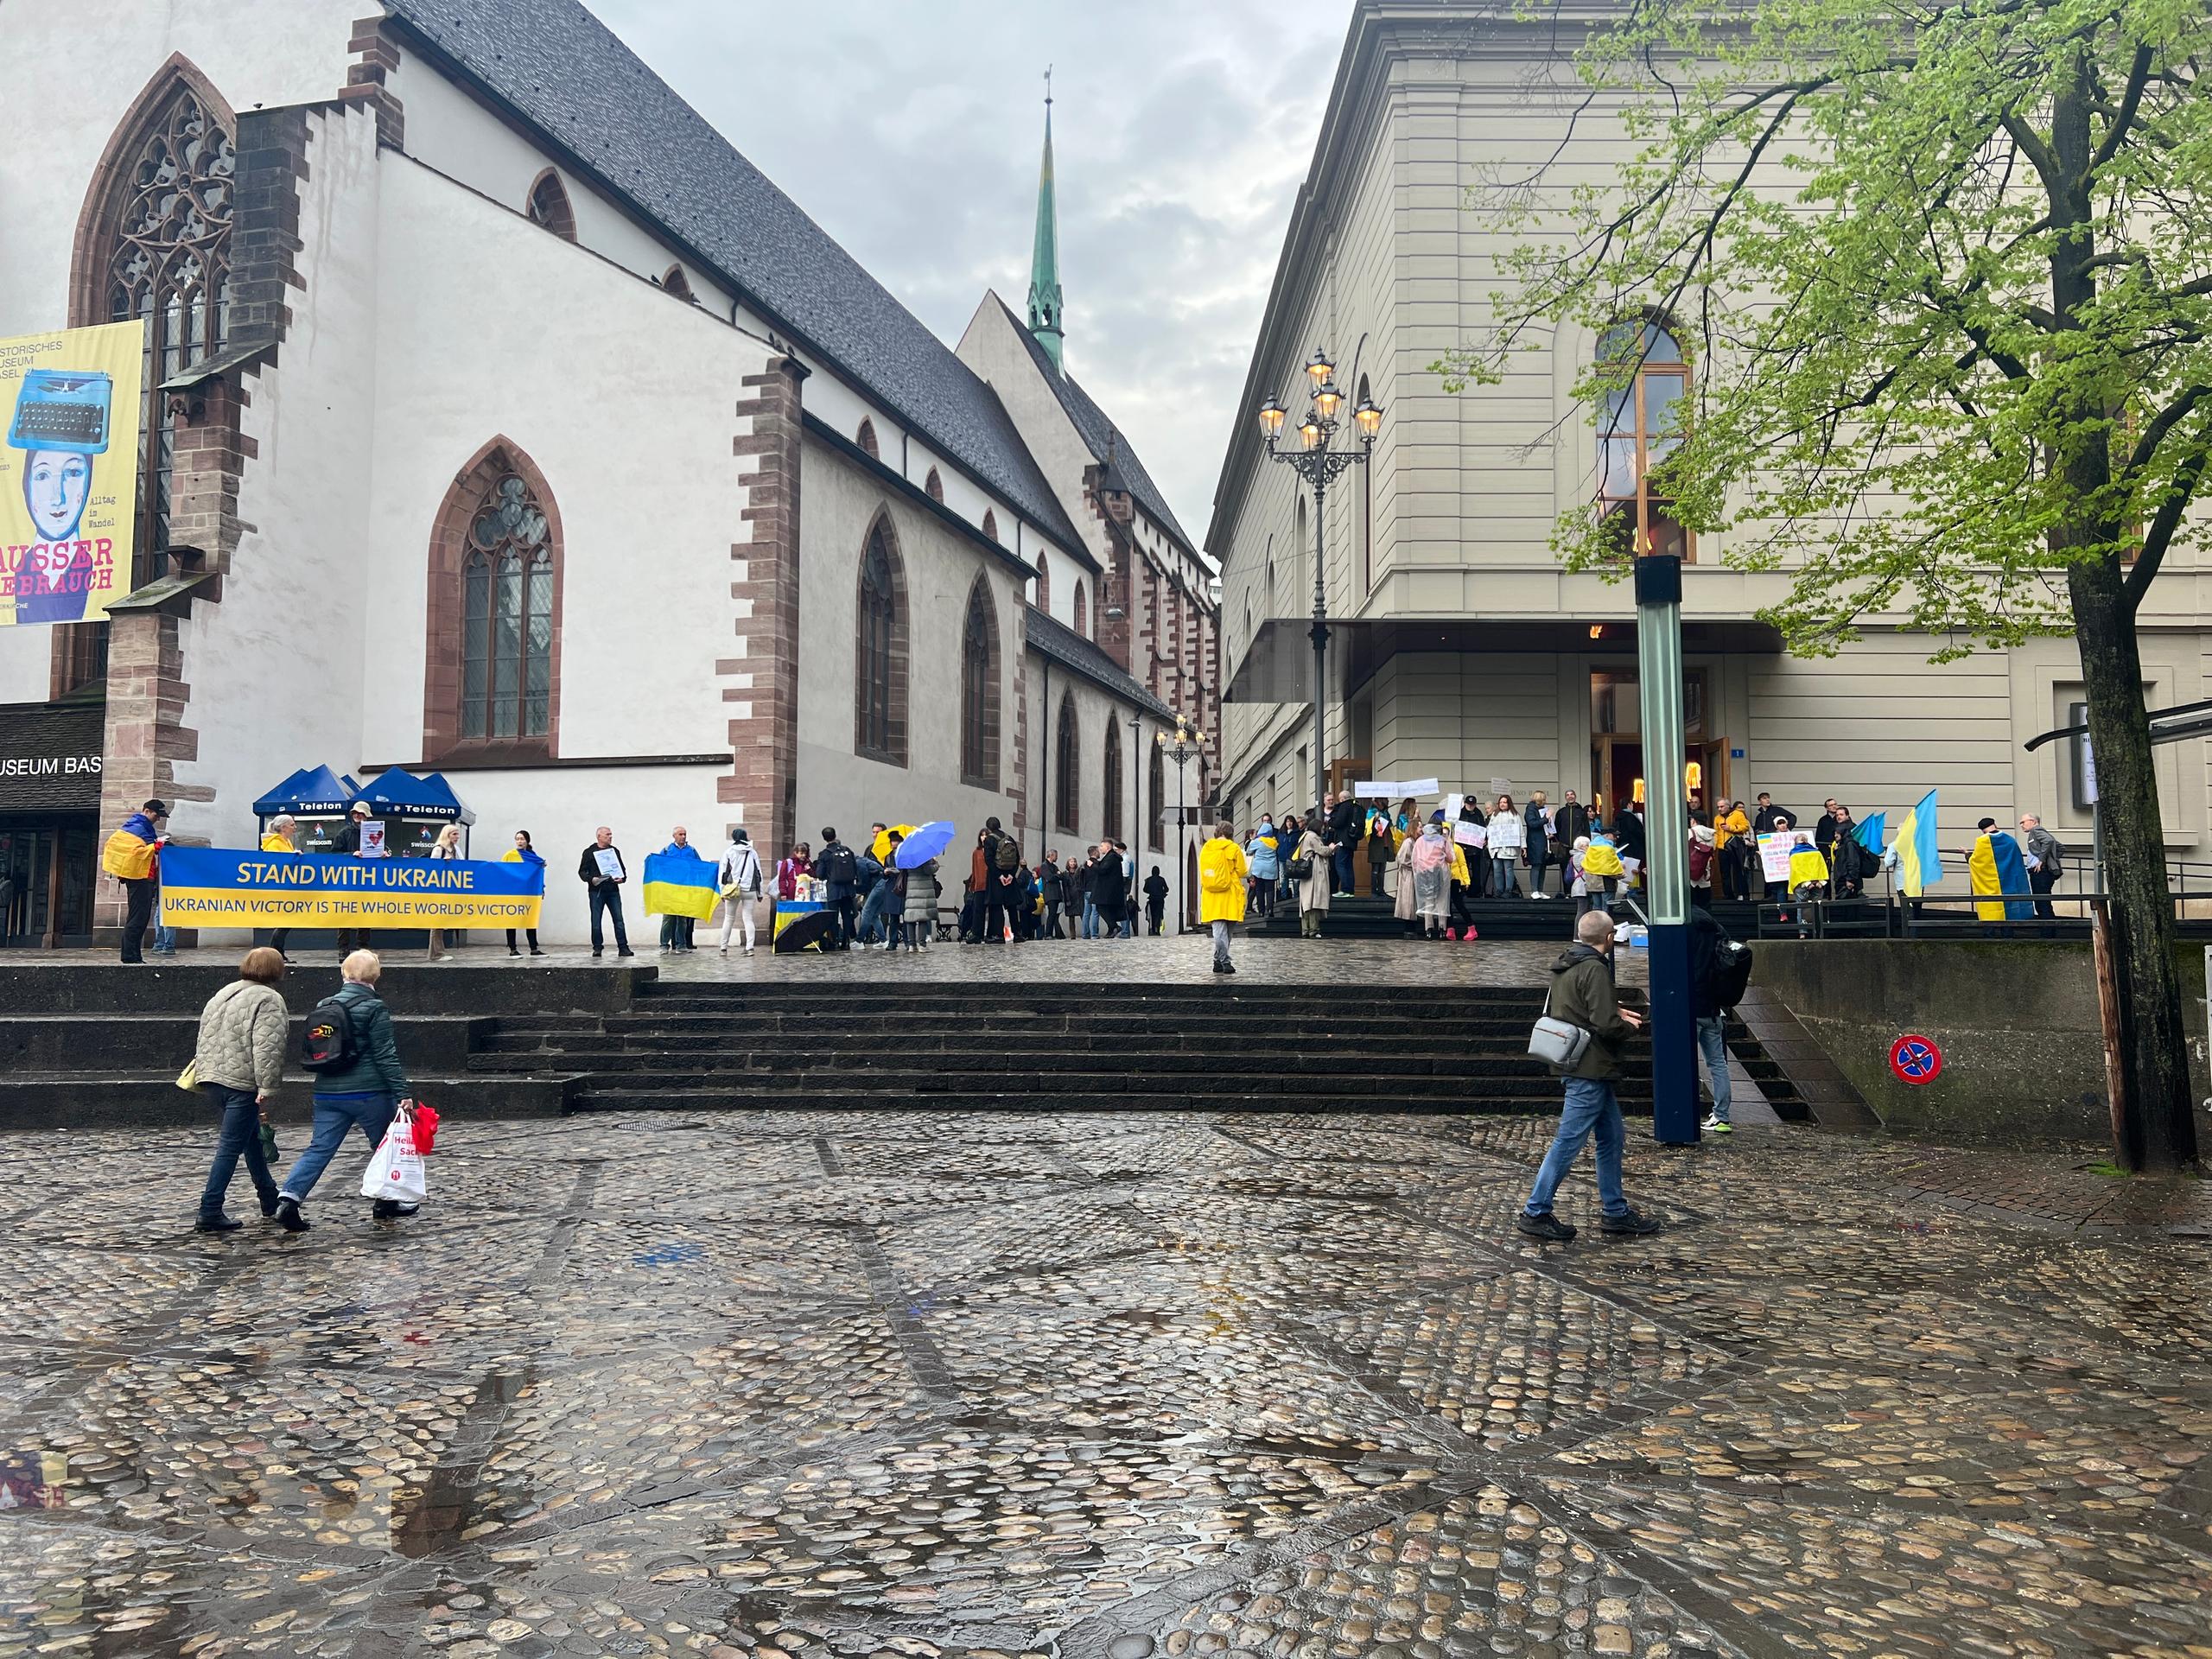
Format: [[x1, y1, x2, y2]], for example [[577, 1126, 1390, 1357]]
[[2066, 560, 2196, 1170]]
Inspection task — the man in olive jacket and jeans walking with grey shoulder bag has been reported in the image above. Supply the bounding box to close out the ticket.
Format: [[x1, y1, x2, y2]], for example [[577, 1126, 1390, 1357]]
[[1513, 909, 1659, 1243]]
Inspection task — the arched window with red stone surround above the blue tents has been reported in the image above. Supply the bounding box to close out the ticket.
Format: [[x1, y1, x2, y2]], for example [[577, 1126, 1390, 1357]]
[[423, 438, 562, 757]]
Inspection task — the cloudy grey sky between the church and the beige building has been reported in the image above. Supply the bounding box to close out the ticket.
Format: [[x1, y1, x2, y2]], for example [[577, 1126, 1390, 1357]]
[[588, 0, 1351, 537]]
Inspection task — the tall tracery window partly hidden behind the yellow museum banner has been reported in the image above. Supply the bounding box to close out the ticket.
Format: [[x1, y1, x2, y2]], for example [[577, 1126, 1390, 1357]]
[[102, 84, 238, 588]]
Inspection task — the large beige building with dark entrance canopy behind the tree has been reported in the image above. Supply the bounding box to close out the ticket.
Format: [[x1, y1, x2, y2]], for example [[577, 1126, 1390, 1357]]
[[1205, 0, 2212, 885]]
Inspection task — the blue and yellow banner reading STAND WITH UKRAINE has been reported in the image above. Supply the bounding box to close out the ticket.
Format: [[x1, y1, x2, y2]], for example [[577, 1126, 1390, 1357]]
[[162, 842, 546, 927]]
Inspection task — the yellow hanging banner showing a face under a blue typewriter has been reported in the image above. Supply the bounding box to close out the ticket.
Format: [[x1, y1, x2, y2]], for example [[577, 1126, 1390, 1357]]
[[0, 323, 146, 628]]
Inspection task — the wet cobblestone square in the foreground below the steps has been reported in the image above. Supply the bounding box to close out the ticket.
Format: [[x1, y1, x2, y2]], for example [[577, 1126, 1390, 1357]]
[[0, 1113, 2212, 1659]]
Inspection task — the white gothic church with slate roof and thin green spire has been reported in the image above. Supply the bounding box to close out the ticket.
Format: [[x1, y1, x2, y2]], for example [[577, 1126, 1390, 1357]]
[[0, 0, 1219, 947]]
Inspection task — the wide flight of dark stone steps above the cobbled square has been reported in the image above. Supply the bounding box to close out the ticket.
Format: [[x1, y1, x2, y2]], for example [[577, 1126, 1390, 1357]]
[[469, 980, 1808, 1117]]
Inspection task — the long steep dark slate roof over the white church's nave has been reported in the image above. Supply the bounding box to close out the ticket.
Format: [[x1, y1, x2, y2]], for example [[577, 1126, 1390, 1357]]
[[383, 0, 1082, 559]]
